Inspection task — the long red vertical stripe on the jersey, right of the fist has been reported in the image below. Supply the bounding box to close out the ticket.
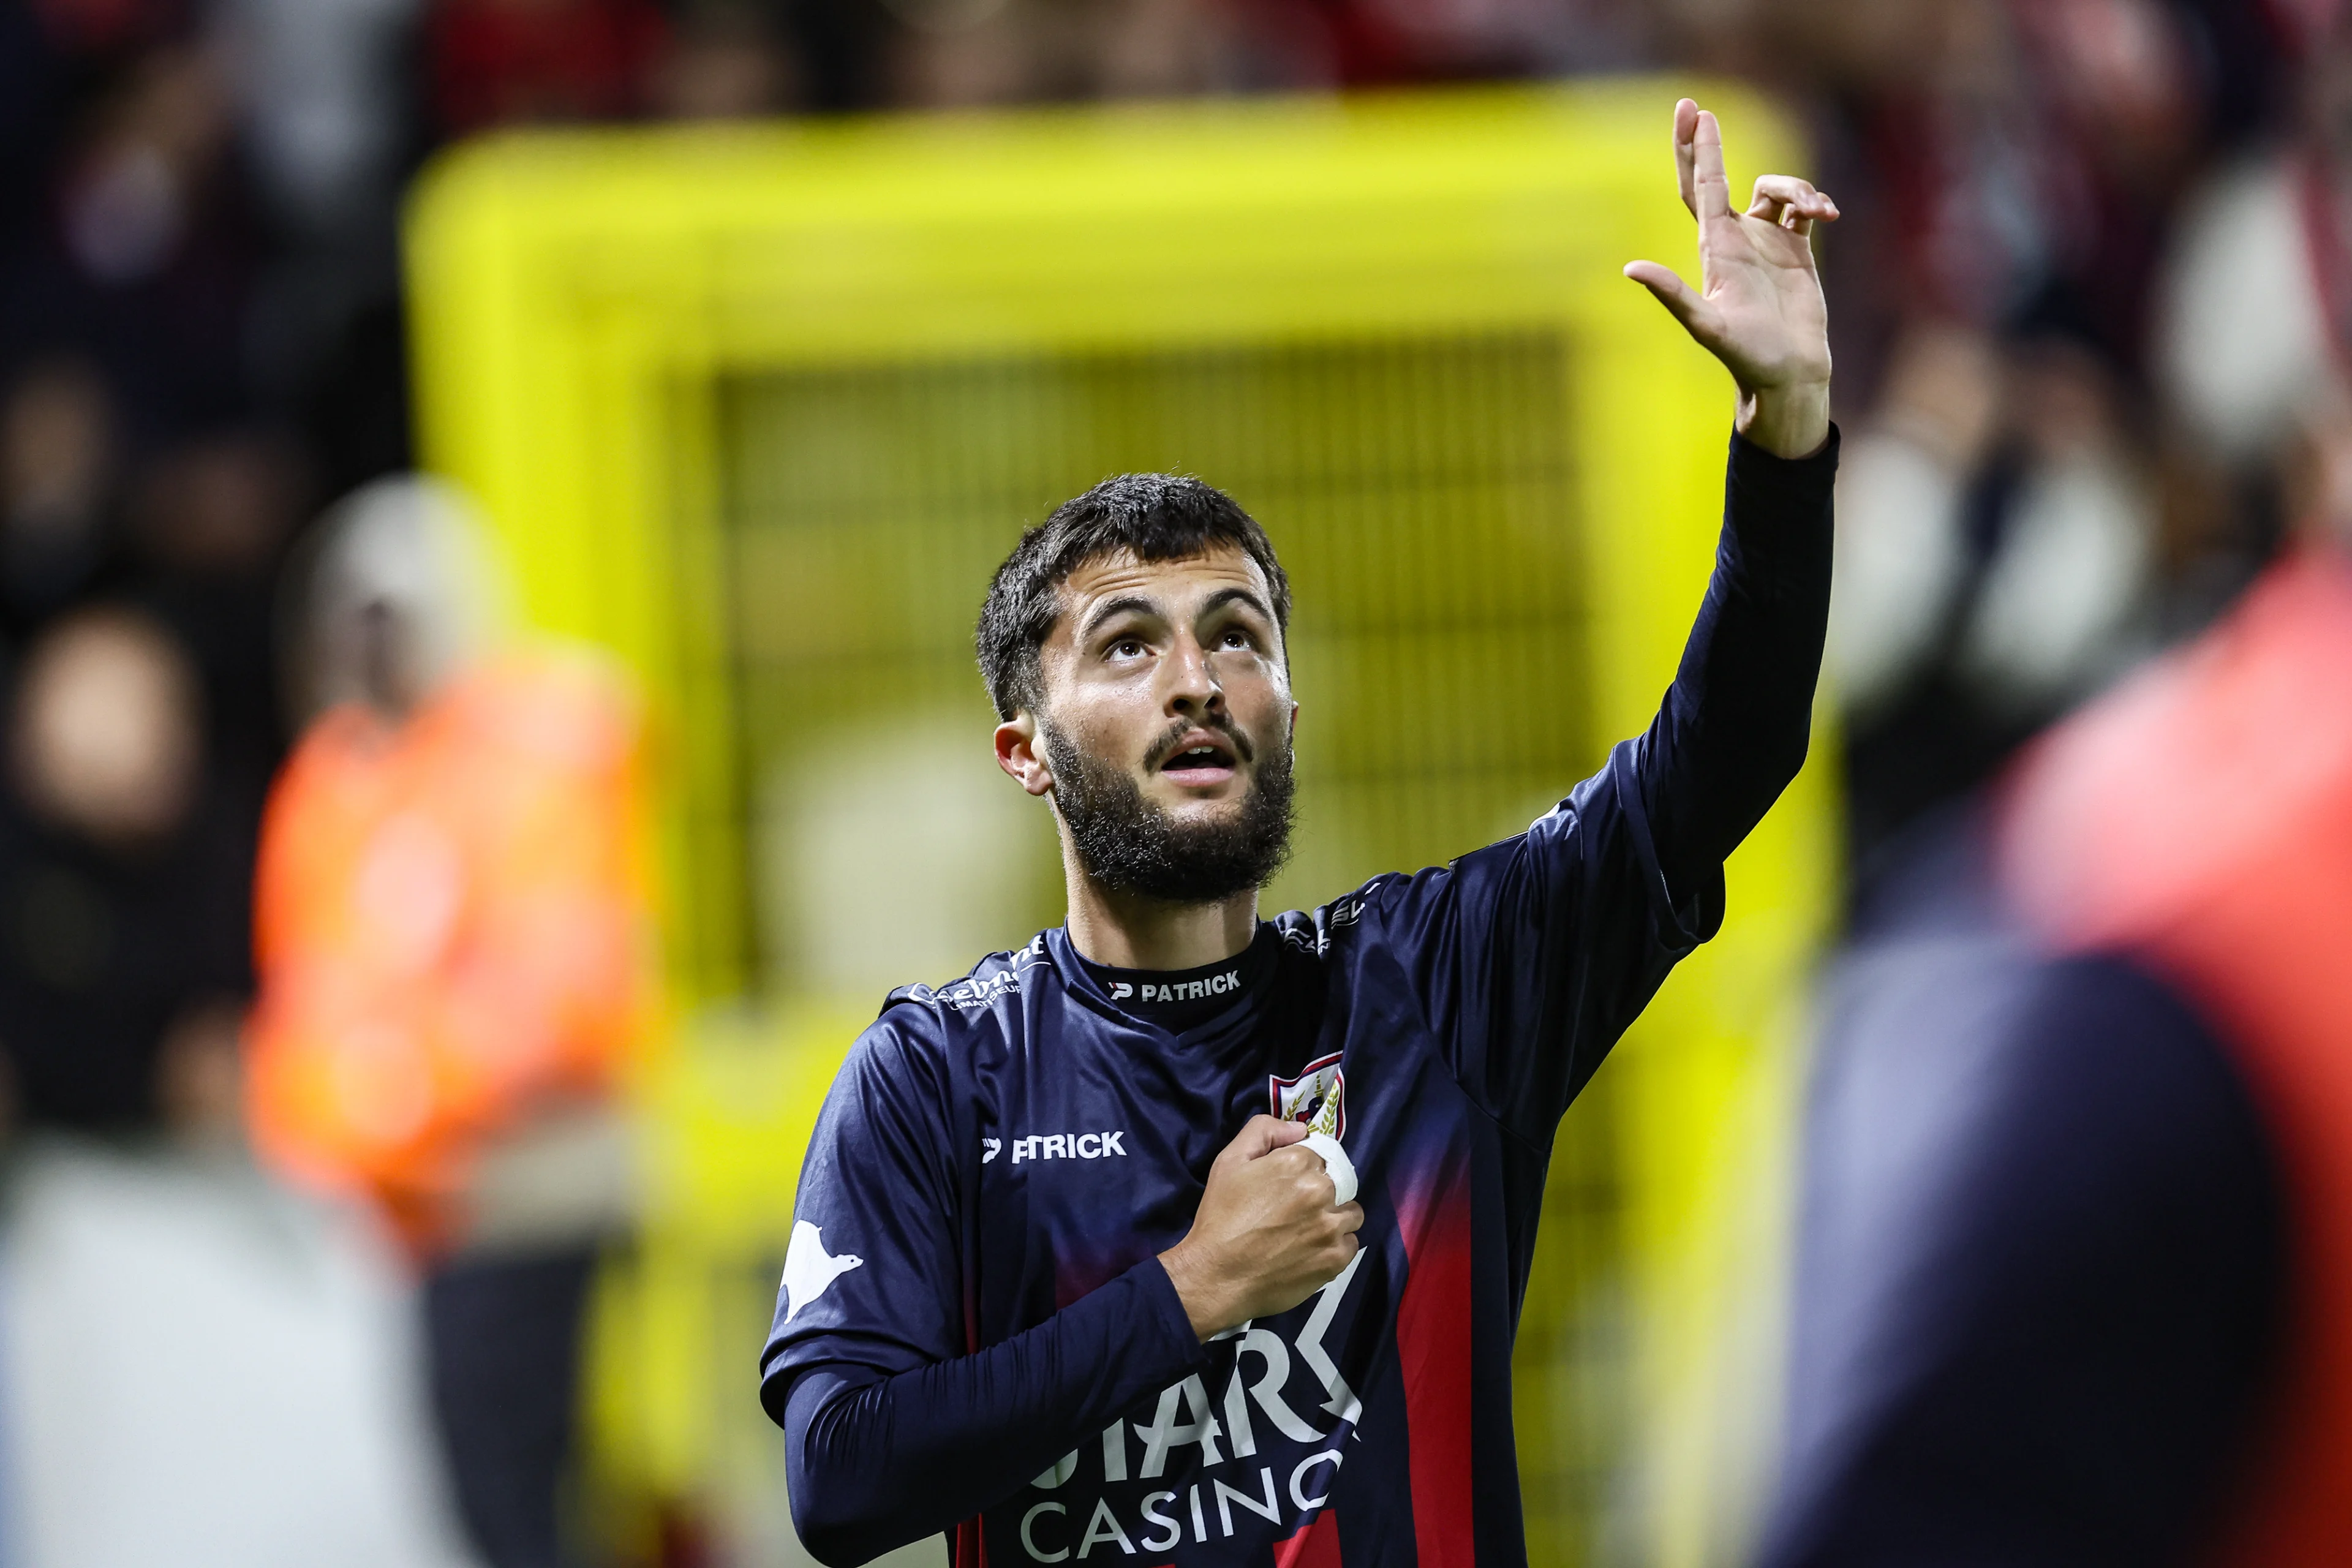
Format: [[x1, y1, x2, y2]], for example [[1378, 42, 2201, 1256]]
[[1397, 1161, 1477, 1568]]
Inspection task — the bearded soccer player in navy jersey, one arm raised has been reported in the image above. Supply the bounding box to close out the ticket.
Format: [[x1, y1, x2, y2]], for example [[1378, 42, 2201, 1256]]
[[762, 99, 1837, 1568]]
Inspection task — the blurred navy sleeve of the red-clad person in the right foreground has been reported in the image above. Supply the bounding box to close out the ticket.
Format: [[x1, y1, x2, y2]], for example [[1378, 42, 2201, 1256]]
[[1759, 809, 2277, 1568]]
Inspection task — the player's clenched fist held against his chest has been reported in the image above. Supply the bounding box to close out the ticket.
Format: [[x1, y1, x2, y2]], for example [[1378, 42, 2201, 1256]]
[[1159, 1117, 1364, 1340]]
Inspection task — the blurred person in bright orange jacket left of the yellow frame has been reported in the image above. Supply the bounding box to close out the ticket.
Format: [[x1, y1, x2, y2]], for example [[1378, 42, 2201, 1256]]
[[247, 480, 654, 1568]]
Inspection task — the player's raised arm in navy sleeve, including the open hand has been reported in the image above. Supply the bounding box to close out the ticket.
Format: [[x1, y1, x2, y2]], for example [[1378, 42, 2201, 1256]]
[[1270, 99, 1837, 1142]]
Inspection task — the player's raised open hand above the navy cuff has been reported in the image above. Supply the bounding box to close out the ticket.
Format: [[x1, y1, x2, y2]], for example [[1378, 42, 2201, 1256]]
[[1625, 99, 1837, 458]]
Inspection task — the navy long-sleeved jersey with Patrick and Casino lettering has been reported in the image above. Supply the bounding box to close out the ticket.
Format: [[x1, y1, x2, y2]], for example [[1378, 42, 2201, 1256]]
[[762, 430, 1834, 1568]]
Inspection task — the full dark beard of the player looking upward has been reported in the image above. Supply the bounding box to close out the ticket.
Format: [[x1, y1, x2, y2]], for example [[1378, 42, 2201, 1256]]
[[1039, 722, 1294, 903]]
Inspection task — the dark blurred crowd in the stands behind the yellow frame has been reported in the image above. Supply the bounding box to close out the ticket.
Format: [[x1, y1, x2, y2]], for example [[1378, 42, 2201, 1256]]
[[0, 0, 2352, 1568]]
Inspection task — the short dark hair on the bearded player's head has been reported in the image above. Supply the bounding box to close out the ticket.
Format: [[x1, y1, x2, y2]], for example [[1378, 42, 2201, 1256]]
[[974, 472, 1291, 719]]
